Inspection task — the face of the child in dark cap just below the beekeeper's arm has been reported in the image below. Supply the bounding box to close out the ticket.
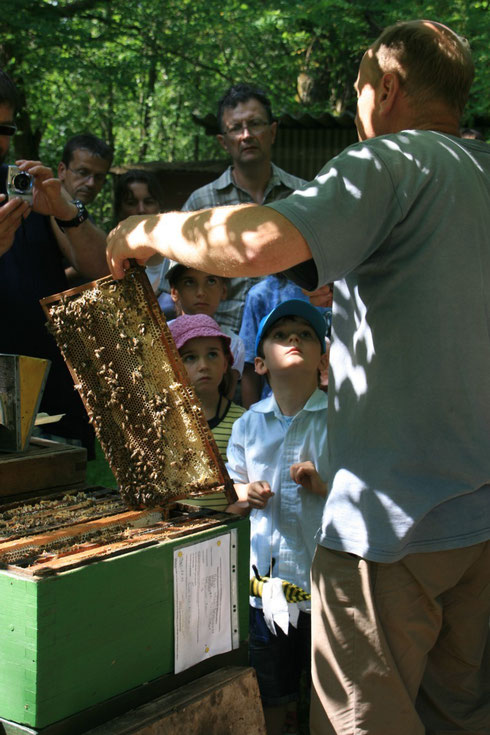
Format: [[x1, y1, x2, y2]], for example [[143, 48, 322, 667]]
[[170, 268, 226, 316]]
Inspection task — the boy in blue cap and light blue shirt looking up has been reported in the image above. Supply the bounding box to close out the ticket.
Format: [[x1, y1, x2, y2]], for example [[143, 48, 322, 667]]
[[227, 299, 327, 735]]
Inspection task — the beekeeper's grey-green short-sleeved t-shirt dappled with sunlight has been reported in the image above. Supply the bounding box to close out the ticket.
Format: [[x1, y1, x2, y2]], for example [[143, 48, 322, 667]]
[[268, 130, 490, 561]]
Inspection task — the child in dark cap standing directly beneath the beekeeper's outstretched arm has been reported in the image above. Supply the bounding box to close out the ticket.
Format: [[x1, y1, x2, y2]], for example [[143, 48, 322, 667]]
[[166, 263, 245, 399]]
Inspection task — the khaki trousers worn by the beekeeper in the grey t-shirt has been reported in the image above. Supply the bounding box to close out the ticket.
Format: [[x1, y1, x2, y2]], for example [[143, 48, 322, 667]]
[[310, 542, 490, 735]]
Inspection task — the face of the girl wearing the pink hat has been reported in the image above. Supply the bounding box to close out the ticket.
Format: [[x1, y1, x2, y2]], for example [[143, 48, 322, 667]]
[[179, 337, 228, 395]]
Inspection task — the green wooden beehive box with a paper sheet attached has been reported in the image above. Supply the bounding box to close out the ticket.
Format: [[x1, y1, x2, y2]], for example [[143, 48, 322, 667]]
[[0, 515, 249, 734]]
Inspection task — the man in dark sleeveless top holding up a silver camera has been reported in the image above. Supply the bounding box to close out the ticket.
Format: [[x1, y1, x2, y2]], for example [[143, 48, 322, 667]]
[[0, 70, 108, 454]]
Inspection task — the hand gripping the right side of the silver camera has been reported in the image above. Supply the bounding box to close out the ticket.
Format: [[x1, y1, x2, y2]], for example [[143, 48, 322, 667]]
[[16, 160, 78, 220]]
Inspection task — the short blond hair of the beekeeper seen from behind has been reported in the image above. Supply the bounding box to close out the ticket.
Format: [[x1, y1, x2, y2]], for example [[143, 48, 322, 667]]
[[371, 20, 475, 115]]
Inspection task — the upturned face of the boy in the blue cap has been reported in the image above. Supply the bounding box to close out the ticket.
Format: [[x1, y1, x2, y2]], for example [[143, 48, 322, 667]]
[[255, 317, 322, 375]]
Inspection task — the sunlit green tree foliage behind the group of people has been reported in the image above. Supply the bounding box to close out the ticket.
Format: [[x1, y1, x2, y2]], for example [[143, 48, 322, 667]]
[[0, 0, 490, 224]]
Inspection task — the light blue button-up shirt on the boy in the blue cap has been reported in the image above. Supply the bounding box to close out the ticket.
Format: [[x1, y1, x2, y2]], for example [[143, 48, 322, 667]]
[[227, 390, 328, 607]]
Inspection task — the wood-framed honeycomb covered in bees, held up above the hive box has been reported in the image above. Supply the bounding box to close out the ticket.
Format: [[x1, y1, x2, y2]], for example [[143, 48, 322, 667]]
[[41, 266, 235, 507]]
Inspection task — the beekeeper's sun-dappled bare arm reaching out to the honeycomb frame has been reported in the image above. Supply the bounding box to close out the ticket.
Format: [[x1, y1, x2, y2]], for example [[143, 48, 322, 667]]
[[107, 204, 311, 278]]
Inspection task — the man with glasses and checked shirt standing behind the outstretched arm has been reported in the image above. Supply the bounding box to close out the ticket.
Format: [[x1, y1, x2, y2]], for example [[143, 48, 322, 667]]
[[157, 83, 305, 333]]
